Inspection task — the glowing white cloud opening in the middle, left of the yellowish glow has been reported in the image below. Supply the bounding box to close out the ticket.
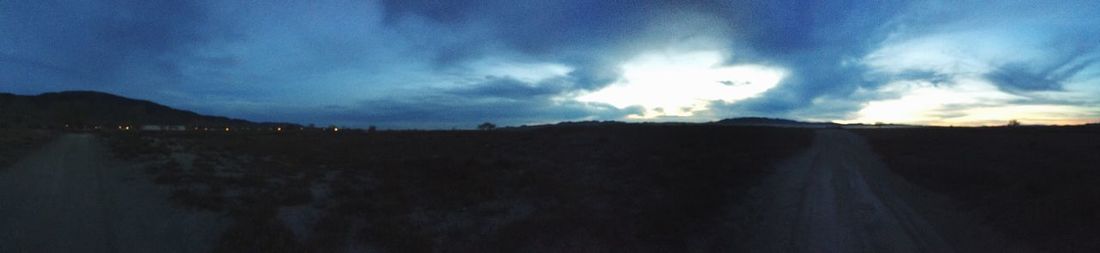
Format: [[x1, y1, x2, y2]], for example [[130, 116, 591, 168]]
[[578, 51, 785, 119]]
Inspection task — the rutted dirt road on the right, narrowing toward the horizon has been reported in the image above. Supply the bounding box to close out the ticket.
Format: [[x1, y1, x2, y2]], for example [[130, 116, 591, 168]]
[[747, 130, 953, 252]]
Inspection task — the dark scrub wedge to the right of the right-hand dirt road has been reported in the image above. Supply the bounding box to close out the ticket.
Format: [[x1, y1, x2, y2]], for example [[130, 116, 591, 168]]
[[860, 127, 1100, 252]]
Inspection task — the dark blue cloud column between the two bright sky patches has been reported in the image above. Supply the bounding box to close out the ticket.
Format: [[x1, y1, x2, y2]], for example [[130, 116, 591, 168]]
[[716, 1, 906, 118]]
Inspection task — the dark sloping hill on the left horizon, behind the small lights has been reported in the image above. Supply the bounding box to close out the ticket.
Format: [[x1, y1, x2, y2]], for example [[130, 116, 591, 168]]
[[0, 91, 292, 128]]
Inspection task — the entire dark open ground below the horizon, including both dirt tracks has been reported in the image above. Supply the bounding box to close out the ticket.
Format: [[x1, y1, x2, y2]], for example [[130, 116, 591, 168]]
[[12, 124, 1100, 252]]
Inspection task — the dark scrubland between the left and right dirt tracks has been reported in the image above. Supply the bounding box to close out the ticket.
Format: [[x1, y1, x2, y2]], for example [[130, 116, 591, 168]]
[[111, 124, 812, 252]]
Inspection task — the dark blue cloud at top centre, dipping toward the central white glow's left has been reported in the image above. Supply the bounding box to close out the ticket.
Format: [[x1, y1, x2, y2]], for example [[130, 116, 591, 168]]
[[383, 0, 721, 90]]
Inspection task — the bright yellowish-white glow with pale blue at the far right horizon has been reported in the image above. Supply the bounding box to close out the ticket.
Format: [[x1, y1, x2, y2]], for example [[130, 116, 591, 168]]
[[838, 29, 1100, 125]]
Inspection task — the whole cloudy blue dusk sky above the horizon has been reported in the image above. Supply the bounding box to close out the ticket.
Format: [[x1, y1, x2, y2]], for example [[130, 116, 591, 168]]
[[0, 0, 1100, 129]]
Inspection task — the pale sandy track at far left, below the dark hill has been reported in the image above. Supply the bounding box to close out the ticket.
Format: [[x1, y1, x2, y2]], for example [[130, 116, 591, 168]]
[[0, 134, 227, 252]]
